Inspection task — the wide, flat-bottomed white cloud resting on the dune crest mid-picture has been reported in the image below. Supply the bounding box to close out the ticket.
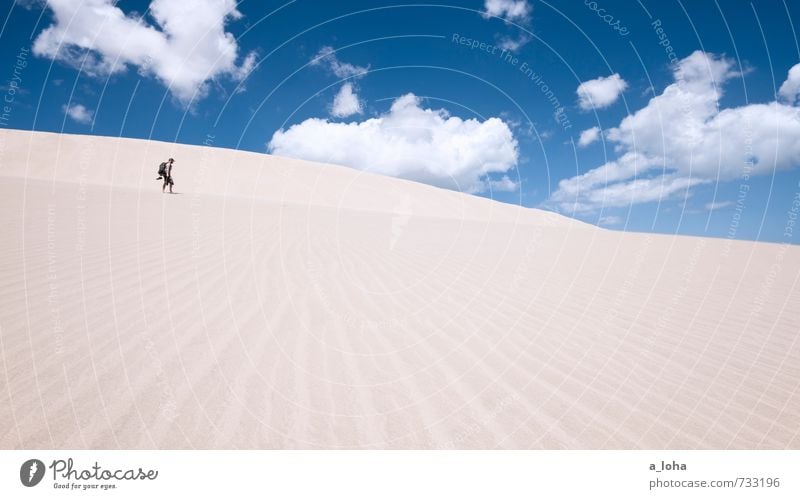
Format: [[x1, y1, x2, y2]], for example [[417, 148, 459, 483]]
[[267, 94, 519, 192]]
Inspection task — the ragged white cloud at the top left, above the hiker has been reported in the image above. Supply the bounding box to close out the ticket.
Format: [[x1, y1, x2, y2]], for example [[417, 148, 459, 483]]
[[33, 0, 255, 105]]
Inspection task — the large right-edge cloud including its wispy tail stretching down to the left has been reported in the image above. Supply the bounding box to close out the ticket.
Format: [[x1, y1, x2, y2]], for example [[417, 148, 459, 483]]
[[549, 51, 800, 212]]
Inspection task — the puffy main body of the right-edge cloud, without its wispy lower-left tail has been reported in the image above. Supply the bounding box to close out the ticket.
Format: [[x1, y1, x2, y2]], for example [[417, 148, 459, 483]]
[[608, 51, 800, 180]]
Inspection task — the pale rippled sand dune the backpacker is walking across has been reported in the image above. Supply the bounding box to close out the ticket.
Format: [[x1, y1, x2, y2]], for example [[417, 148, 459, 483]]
[[0, 131, 800, 449]]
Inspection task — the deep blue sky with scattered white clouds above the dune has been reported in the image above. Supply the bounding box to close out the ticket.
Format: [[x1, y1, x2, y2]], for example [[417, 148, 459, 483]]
[[0, 0, 800, 243]]
